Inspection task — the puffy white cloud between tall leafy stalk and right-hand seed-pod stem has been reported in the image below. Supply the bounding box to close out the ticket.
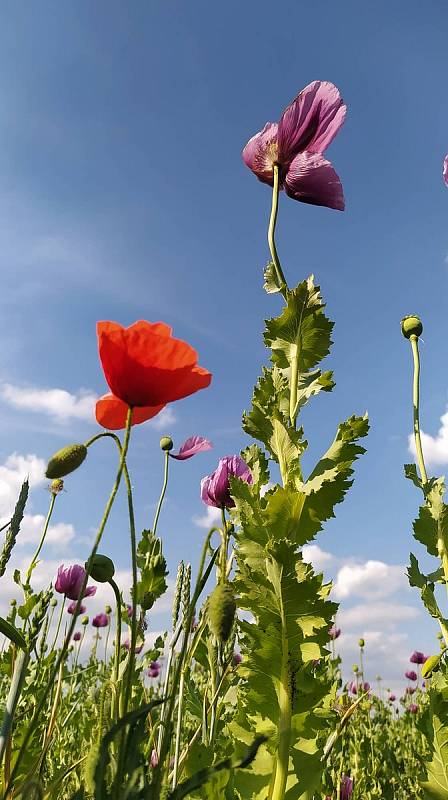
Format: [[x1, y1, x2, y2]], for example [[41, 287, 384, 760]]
[[334, 560, 408, 600]]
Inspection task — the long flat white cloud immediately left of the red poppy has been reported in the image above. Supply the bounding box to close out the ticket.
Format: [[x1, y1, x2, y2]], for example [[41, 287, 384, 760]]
[[0, 383, 97, 422]]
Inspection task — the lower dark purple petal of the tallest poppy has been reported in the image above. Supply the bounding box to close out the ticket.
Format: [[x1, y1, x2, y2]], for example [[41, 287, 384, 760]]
[[285, 153, 345, 211]]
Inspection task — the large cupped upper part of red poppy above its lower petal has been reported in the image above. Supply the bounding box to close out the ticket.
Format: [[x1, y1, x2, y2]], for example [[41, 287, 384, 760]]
[[97, 320, 212, 424]]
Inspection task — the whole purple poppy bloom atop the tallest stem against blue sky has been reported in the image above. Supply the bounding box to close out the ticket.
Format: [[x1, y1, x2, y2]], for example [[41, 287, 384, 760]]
[[243, 81, 347, 211]]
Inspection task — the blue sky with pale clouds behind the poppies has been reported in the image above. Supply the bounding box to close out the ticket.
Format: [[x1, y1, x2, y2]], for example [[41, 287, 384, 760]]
[[0, 0, 448, 680]]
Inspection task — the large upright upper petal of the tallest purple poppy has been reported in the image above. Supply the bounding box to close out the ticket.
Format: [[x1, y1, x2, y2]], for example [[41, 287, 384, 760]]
[[278, 81, 347, 164]]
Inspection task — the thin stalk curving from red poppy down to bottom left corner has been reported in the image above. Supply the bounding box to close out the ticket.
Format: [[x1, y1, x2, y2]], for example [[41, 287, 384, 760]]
[[3, 408, 132, 800]]
